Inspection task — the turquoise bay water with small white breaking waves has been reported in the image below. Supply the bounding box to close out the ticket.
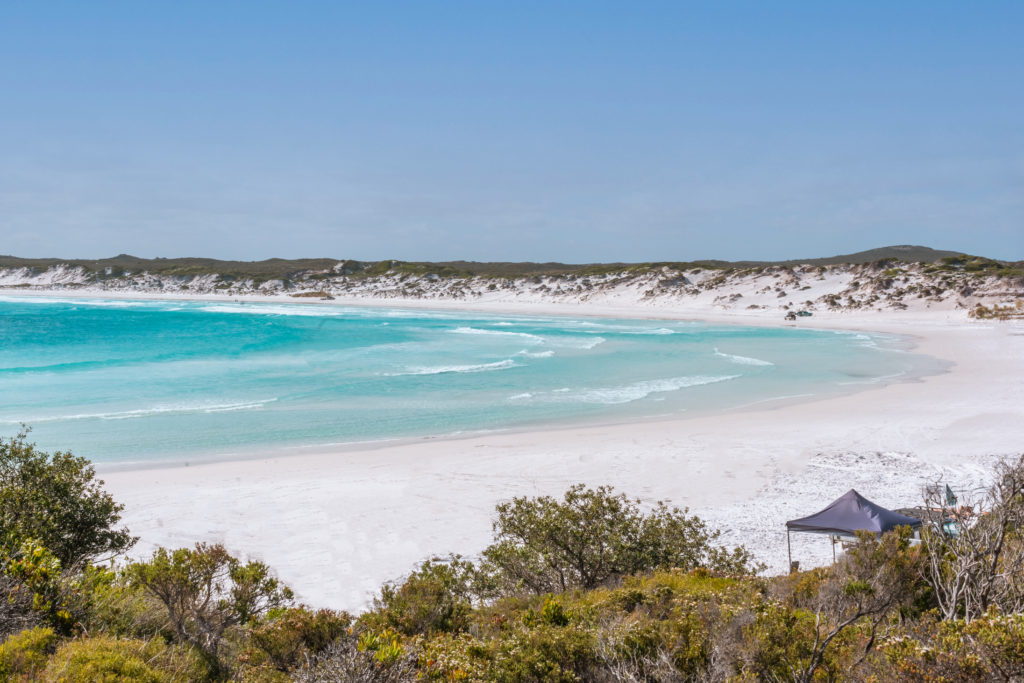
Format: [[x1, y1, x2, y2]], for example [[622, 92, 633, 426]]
[[0, 297, 937, 465]]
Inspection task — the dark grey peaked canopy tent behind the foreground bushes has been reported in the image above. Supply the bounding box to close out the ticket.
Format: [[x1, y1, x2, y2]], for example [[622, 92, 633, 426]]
[[785, 488, 922, 570]]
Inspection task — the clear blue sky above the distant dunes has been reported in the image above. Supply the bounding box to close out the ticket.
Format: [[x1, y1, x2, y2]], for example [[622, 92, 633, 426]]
[[0, 0, 1024, 263]]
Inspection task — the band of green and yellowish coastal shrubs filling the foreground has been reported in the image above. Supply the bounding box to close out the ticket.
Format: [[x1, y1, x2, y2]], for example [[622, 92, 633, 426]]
[[0, 433, 1024, 682]]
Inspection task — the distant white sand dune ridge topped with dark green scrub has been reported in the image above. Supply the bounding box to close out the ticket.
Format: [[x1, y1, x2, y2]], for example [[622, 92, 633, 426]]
[[0, 245, 1024, 316]]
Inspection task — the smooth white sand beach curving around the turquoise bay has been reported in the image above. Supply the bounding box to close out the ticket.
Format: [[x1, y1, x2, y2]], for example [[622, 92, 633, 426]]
[[83, 299, 1024, 610]]
